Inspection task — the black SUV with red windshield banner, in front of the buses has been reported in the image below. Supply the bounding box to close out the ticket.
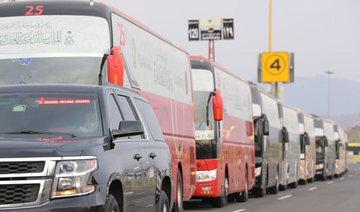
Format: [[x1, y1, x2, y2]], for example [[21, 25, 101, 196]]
[[0, 85, 173, 212]]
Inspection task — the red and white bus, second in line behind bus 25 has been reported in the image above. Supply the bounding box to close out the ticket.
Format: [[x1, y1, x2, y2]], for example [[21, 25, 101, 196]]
[[191, 56, 255, 207]]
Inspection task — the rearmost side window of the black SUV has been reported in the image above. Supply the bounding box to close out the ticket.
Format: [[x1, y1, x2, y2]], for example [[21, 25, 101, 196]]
[[134, 98, 164, 141]]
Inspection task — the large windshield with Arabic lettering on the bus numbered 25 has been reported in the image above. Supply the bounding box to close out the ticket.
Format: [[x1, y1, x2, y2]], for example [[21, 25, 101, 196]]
[[0, 15, 110, 85]]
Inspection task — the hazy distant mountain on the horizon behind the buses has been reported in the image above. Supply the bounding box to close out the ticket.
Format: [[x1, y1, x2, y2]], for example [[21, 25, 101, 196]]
[[284, 76, 360, 117]]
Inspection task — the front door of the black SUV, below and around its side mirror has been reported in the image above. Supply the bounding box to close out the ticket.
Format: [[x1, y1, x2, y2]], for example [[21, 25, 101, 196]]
[[107, 93, 145, 211]]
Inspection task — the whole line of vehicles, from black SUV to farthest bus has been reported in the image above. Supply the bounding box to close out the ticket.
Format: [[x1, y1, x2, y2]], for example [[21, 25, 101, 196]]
[[0, 1, 347, 212]]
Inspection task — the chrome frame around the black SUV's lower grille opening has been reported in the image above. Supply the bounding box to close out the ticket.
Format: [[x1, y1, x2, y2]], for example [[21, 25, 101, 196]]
[[0, 180, 52, 210]]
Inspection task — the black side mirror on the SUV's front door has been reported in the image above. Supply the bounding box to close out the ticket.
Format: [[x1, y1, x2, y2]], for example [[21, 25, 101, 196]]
[[111, 121, 144, 138]]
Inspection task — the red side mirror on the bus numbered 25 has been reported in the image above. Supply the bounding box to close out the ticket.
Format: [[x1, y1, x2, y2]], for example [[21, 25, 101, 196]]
[[108, 46, 124, 86]]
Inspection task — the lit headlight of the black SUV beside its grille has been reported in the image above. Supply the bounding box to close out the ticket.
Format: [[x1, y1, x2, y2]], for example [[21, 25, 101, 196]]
[[52, 159, 98, 198]]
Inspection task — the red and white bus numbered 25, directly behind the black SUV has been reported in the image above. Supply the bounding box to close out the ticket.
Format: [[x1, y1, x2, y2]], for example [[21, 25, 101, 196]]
[[0, 1, 196, 211]]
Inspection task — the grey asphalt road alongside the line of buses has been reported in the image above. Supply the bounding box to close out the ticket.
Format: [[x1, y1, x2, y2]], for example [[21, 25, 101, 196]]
[[185, 165, 360, 212]]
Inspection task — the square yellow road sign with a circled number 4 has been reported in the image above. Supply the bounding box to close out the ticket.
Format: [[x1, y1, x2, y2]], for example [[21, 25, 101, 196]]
[[261, 52, 290, 83]]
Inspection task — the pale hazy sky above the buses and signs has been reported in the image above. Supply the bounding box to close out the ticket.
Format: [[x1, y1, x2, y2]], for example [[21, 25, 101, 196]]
[[102, 0, 360, 82]]
